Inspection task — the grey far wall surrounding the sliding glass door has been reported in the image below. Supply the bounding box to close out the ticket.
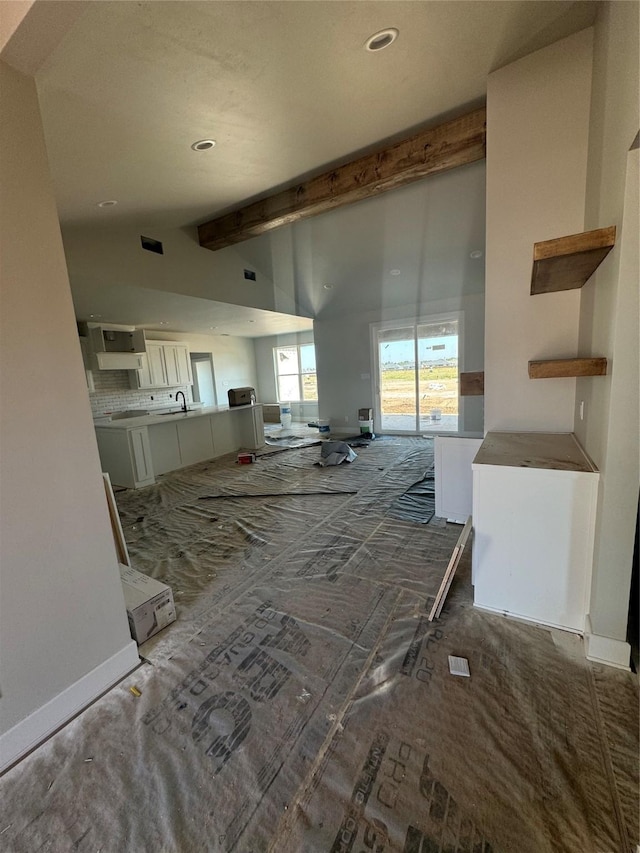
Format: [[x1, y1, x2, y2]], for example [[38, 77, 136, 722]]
[[314, 294, 484, 433]]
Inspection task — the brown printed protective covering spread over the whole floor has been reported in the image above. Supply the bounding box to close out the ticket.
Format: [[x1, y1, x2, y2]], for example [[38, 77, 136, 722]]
[[0, 438, 638, 853]]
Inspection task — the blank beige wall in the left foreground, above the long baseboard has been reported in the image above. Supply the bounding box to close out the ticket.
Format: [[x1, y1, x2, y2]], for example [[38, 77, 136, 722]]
[[0, 63, 137, 753]]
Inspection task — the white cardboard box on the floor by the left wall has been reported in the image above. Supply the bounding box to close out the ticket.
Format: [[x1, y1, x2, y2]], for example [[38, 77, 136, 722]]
[[120, 563, 176, 645]]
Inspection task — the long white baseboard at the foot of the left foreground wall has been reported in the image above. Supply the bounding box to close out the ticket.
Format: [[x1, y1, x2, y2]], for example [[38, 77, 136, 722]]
[[0, 640, 140, 772]]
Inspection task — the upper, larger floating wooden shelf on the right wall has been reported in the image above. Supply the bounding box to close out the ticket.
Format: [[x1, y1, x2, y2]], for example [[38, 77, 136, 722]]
[[531, 225, 616, 295]]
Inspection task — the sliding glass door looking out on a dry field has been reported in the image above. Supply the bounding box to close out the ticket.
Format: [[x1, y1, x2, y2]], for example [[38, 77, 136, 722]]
[[373, 314, 461, 434]]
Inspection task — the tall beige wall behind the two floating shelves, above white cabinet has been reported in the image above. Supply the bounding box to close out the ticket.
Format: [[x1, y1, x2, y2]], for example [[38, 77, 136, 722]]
[[485, 29, 593, 432]]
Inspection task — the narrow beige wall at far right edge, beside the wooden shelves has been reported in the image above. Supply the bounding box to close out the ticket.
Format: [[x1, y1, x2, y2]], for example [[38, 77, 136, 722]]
[[575, 3, 640, 640]]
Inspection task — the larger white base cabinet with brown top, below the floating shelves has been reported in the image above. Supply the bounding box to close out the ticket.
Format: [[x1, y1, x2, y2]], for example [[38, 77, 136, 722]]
[[472, 432, 599, 633]]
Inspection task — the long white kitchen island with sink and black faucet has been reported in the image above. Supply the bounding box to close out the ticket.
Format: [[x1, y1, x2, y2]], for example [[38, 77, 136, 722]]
[[95, 403, 264, 489]]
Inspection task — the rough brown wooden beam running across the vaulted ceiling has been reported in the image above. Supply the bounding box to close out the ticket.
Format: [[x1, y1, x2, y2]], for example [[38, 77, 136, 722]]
[[198, 107, 487, 251]]
